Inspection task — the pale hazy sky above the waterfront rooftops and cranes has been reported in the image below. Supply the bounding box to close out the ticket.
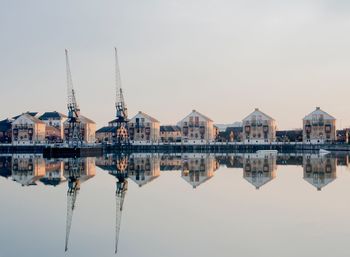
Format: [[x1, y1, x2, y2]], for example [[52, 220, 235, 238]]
[[0, 0, 350, 129]]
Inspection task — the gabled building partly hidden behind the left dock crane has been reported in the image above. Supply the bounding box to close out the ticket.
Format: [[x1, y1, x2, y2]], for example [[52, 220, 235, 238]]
[[63, 115, 96, 144]]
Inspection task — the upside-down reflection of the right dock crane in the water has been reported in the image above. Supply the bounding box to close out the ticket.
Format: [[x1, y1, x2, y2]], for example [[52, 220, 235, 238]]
[[110, 156, 128, 253]]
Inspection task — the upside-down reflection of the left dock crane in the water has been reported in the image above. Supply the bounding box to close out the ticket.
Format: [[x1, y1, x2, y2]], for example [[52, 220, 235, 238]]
[[64, 159, 80, 252]]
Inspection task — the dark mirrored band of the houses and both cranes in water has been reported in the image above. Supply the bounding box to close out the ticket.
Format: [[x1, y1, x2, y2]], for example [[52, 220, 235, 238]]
[[0, 153, 349, 253]]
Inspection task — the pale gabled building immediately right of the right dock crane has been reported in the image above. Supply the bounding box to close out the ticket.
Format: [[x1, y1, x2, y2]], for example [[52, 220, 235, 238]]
[[128, 111, 160, 144]]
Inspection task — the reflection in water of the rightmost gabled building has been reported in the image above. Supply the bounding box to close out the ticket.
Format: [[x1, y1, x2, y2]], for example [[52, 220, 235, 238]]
[[303, 155, 337, 191]]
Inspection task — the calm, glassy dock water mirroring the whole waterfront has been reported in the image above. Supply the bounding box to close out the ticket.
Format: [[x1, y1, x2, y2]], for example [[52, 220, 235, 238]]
[[0, 153, 350, 257]]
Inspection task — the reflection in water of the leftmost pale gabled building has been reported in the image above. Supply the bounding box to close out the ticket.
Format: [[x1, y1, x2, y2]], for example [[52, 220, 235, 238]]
[[12, 154, 45, 186]]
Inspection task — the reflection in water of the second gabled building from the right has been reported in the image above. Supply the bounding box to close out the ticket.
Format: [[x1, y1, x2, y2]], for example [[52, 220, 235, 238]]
[[243, 153, 277, 189]]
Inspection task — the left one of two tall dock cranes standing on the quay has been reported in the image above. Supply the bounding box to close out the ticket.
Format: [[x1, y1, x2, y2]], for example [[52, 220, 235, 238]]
[[64, 49, 82, 147]]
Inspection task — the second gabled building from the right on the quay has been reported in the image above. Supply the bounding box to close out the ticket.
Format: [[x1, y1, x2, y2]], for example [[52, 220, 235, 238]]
[[243, 108, 277, 144]]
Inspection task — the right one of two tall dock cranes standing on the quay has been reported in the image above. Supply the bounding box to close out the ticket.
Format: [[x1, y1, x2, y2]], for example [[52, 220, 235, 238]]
[[114, 47, 128, 144]]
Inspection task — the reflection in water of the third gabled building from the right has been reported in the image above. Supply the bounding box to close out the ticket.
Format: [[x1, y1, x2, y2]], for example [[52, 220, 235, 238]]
[[181, 153, 219, 188]]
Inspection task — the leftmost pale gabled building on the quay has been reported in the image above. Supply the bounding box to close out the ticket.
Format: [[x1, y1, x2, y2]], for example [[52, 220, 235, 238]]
[[12, 113, 46, 145]]
